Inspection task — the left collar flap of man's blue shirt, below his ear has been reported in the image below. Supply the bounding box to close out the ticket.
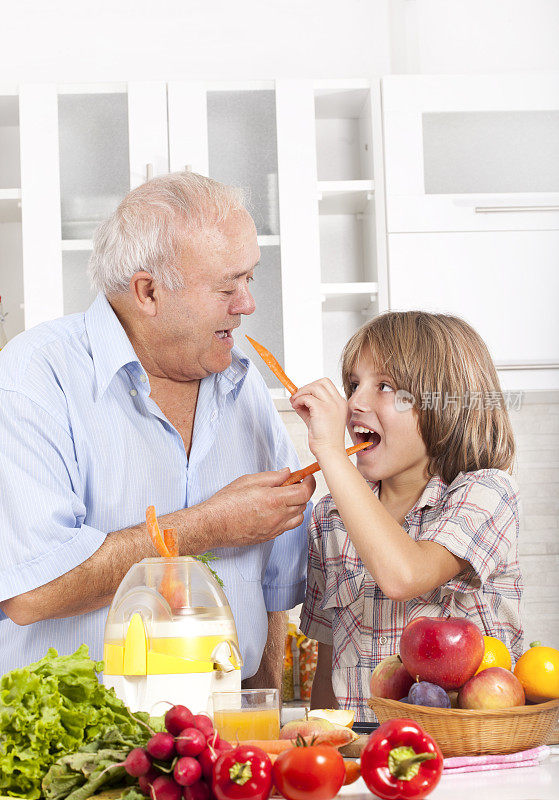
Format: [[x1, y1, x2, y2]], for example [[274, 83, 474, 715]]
[[85, 292, 143, 401]]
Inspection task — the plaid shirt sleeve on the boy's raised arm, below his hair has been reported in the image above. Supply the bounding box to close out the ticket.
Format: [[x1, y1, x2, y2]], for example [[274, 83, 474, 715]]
[[417, 469, 519, 591]]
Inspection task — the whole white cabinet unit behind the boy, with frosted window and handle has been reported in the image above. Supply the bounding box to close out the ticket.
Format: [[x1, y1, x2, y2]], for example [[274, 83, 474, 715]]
[[382, 74, 559, 390]]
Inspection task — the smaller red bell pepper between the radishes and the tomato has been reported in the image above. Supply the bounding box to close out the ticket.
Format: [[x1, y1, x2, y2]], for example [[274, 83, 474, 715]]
[[212, 745, 272, 800]]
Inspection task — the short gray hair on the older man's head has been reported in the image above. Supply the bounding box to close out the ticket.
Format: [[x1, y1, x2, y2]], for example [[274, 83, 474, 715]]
[[88, 172, 245, 294]]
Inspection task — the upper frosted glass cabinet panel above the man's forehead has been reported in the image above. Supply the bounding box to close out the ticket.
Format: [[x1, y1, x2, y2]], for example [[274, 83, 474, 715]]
[[207, 89, 280, 236]]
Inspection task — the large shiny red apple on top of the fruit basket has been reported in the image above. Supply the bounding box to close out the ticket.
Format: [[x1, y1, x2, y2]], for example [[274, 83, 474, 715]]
[[400, 617, 485, 691]]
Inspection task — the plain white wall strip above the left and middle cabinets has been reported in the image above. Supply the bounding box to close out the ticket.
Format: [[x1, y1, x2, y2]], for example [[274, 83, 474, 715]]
[[0, 0, 390, 84]]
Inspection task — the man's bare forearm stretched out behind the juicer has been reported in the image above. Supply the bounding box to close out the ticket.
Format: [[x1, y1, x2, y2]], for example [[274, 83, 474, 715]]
[[0, 506, 217, 625]]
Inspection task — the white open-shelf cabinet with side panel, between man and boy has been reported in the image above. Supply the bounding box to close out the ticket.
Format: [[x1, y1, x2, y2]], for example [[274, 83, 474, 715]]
[[276, 81, 387, 384]]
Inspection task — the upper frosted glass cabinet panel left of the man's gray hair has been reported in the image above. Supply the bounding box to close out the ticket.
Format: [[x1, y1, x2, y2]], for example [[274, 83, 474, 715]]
[[58, 93, 130, 239]]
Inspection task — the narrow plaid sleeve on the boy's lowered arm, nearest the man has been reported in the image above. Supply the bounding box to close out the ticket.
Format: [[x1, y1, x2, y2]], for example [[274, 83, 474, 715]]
[[300, 497, 332, 644]]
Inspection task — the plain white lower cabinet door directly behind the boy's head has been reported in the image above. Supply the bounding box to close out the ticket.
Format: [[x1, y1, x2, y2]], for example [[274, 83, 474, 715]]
[[388, 231, 559, 388]]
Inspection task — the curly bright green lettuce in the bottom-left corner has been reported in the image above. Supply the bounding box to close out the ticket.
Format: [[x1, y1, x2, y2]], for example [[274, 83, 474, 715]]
[[0, 644, 150, 800]]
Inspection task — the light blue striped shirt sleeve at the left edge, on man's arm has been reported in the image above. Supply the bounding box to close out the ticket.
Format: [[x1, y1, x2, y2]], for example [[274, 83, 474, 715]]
[[0, 390, 106, 600]]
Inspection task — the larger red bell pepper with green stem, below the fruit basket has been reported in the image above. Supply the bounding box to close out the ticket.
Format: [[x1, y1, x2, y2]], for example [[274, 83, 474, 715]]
[[361, 719, 443, 800]]
